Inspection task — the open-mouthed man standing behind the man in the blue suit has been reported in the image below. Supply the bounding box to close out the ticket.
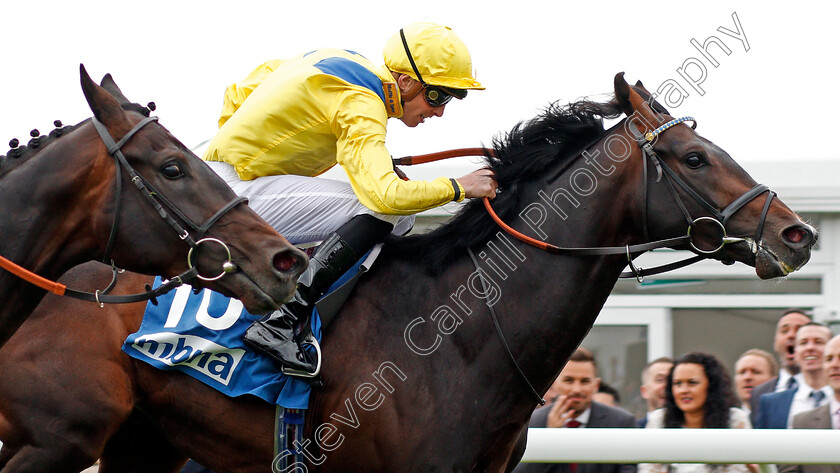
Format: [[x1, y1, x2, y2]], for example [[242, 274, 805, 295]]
[[750, 309, 811, 425]]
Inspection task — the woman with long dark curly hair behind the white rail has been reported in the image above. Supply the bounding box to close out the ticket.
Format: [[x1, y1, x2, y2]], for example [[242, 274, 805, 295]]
[[639, 353, 758, 473]]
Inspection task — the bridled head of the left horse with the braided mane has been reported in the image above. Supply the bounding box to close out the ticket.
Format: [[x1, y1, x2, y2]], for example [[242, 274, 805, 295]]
[[80, 66, 306, 313]]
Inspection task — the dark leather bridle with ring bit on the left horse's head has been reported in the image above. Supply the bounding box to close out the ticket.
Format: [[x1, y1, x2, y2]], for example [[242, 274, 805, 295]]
[[91, 117, 248, 282]]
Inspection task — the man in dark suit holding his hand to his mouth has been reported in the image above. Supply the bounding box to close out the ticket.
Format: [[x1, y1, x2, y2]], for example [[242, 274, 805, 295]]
[[513, 348, 636, 473]]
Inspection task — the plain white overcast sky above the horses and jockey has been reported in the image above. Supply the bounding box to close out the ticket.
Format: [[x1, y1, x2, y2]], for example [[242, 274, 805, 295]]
[[0, 0, 840, 179]]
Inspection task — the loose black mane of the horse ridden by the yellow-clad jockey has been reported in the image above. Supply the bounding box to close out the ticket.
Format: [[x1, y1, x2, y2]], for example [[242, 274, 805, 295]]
[[384, 100, 621, 273]]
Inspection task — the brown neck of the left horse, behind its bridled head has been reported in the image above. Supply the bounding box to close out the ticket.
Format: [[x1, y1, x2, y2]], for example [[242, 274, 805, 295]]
[[0, 127, 111, 296]]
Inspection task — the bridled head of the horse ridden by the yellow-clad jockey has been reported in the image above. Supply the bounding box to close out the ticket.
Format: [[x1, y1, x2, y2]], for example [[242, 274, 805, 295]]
[[614, 73, 817, 279]]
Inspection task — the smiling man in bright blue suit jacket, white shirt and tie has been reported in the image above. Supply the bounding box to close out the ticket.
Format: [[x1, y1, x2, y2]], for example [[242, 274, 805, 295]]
[[755, 322, 833, 429]]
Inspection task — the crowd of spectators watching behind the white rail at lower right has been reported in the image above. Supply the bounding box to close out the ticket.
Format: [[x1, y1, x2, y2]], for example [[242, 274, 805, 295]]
[[514, 310, 840, 473]]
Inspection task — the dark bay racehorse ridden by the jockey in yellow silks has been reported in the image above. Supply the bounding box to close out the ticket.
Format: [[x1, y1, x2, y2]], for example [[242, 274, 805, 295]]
[[0, 74, 817, 473]]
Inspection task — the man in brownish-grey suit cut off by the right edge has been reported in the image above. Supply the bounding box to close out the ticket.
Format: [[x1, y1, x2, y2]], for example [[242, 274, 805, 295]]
[[779, 335, 840, 473]]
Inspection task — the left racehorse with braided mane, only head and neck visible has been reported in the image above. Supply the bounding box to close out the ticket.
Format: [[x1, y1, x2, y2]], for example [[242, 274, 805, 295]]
[[0, 66, 306, 346]]
